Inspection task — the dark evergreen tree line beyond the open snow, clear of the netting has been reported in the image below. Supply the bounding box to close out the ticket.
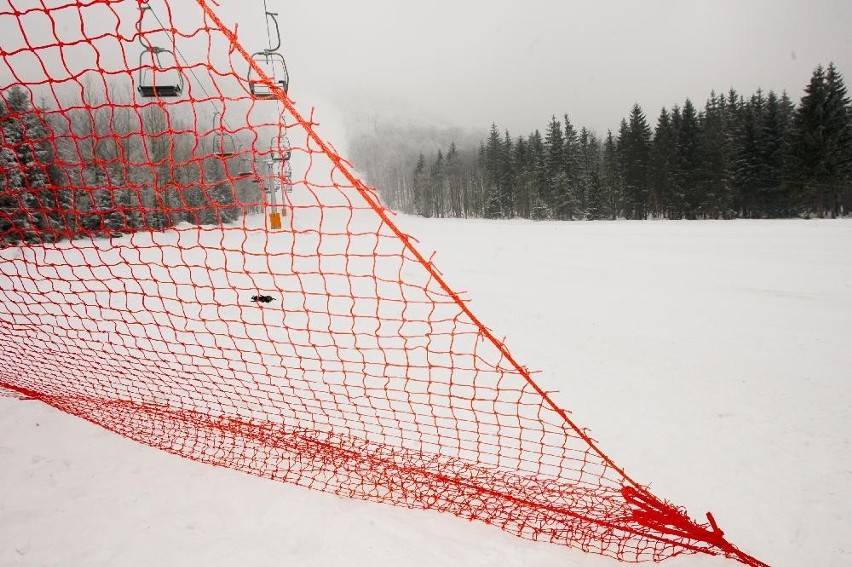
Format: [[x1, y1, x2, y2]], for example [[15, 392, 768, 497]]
[[364, 64, 852, 220]]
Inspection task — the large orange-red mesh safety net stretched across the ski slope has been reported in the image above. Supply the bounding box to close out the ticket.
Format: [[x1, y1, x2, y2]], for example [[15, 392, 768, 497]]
[[0, 0, 763, 565]]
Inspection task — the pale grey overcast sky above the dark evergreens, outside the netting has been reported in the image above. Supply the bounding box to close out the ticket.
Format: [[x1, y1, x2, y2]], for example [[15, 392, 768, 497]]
[[205, 0, 852, 134]]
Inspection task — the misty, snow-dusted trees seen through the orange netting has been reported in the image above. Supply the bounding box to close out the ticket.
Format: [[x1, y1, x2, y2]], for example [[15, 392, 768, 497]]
[[0, 83, 261, 247]]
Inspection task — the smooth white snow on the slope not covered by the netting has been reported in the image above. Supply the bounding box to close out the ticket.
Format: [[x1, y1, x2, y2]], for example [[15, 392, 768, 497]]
[[0, 217, 852, 567]]
